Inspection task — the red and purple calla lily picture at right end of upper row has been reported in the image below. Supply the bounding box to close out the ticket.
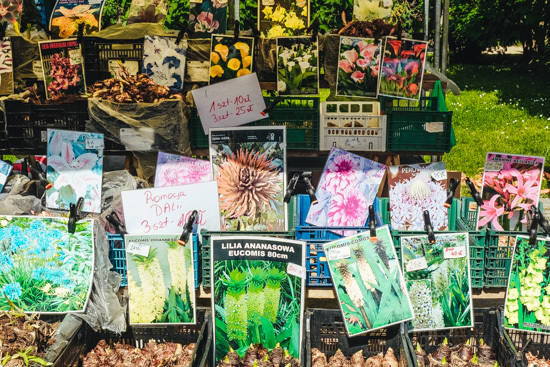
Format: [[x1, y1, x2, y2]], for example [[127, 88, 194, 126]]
[[379, 37, 427, 100]]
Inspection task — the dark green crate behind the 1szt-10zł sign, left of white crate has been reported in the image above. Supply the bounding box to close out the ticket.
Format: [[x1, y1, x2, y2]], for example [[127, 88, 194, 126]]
[[189, 97, 320, 150]]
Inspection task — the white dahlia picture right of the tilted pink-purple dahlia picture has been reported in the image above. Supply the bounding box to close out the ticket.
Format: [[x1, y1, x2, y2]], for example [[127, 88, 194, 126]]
[[388, 162, 449, 231]]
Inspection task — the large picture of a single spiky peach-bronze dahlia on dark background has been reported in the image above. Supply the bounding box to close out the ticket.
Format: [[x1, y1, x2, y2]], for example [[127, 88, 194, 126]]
[[209, 126, 286, 231]]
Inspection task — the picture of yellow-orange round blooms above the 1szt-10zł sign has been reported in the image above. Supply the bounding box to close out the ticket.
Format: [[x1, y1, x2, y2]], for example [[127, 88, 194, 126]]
[[210, 35, 254, 84]]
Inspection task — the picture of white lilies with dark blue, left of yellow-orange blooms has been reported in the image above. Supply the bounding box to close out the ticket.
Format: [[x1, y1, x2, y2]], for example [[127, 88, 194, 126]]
[[143, 36, 187, 91]]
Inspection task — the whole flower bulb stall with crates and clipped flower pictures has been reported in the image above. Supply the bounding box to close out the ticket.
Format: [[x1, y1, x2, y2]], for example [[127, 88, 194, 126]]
[[0, 0, 550, 367]]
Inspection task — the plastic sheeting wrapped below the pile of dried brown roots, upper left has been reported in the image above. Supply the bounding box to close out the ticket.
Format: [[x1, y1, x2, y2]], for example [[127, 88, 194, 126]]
[[86, 98, 191, 155]]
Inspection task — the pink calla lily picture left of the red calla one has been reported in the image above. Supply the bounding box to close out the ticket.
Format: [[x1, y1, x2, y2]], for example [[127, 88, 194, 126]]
[[336, 37, 380, 98]]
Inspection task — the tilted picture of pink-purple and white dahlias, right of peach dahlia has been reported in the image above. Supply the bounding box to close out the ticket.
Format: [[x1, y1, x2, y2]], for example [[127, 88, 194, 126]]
[[306, 147, 386, 227]]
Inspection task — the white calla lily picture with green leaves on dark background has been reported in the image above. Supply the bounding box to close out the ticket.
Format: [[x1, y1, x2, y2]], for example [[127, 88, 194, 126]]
[[277, 37, 319, 96]]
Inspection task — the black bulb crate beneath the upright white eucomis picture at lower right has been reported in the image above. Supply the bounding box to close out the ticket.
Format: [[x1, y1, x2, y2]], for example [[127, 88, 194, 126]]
[[407, 309, 516, 367]]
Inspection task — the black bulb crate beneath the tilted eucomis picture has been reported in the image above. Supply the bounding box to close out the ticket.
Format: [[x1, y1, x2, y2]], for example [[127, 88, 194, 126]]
[[305, 308, 412, 367]]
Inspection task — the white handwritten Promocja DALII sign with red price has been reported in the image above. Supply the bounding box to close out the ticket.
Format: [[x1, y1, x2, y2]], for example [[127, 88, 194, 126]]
[[122, 181, 220, 234]]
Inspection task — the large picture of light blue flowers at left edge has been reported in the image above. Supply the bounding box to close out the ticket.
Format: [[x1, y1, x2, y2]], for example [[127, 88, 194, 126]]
[[0, 216, 94, 314]]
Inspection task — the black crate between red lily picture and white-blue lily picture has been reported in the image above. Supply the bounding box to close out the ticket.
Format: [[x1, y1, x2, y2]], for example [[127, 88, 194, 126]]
[[82, 37, 144, 85]]
